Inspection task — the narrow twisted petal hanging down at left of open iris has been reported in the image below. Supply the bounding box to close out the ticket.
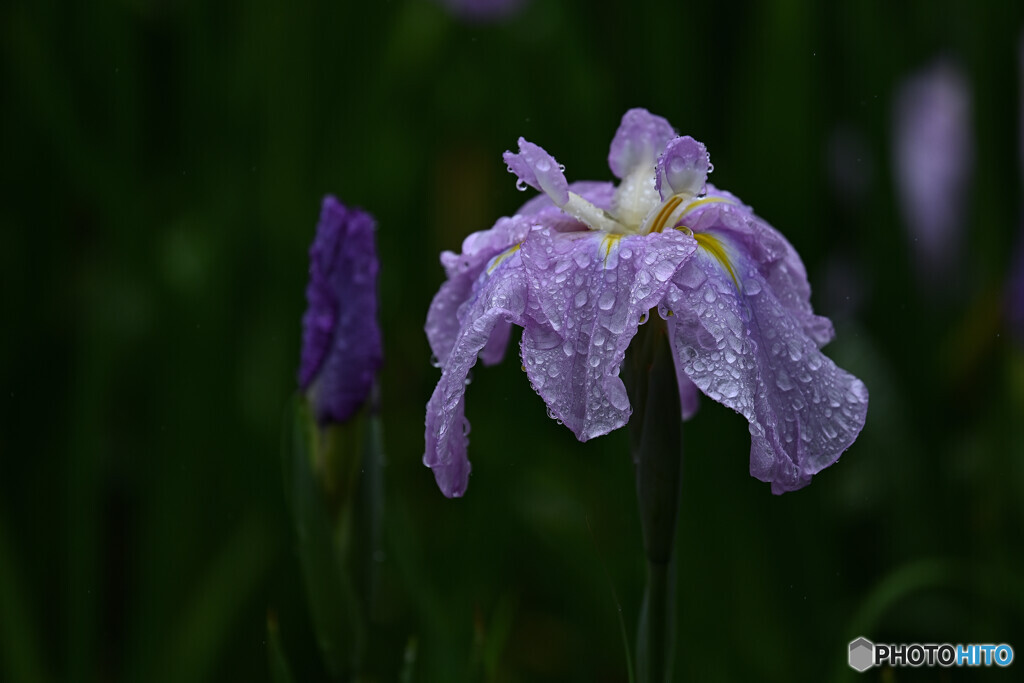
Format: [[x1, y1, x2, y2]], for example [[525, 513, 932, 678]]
[[423, 253, 526, 498]]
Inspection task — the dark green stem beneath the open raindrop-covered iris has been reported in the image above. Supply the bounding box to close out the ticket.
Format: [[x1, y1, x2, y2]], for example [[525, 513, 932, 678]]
[[627, 314, 682, 683]]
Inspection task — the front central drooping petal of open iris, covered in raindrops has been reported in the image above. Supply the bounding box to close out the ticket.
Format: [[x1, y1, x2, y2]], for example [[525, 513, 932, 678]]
[[521, 228, 695, 441]]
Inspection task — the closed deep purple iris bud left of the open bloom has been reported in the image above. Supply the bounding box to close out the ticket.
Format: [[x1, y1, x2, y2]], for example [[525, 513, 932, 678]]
[[298, 196, 383, 425]]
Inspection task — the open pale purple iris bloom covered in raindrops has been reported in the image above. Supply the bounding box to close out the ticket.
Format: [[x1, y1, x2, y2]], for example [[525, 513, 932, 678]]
[[423, 109, 867, 497]]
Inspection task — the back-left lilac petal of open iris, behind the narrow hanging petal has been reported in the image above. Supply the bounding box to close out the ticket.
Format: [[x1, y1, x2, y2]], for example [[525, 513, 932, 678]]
[[424, 214, 536, 365]]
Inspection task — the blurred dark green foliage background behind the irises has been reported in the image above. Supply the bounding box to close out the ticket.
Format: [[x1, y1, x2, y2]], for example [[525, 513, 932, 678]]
[[0, 0, 1024, 683]]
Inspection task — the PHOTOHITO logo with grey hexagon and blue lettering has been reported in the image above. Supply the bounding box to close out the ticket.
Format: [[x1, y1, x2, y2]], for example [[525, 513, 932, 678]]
[[849, 637, 1014, 673]]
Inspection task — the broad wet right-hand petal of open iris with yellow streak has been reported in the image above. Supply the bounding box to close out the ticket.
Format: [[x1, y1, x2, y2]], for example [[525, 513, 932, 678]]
[[665, 230, 867, 494]]
